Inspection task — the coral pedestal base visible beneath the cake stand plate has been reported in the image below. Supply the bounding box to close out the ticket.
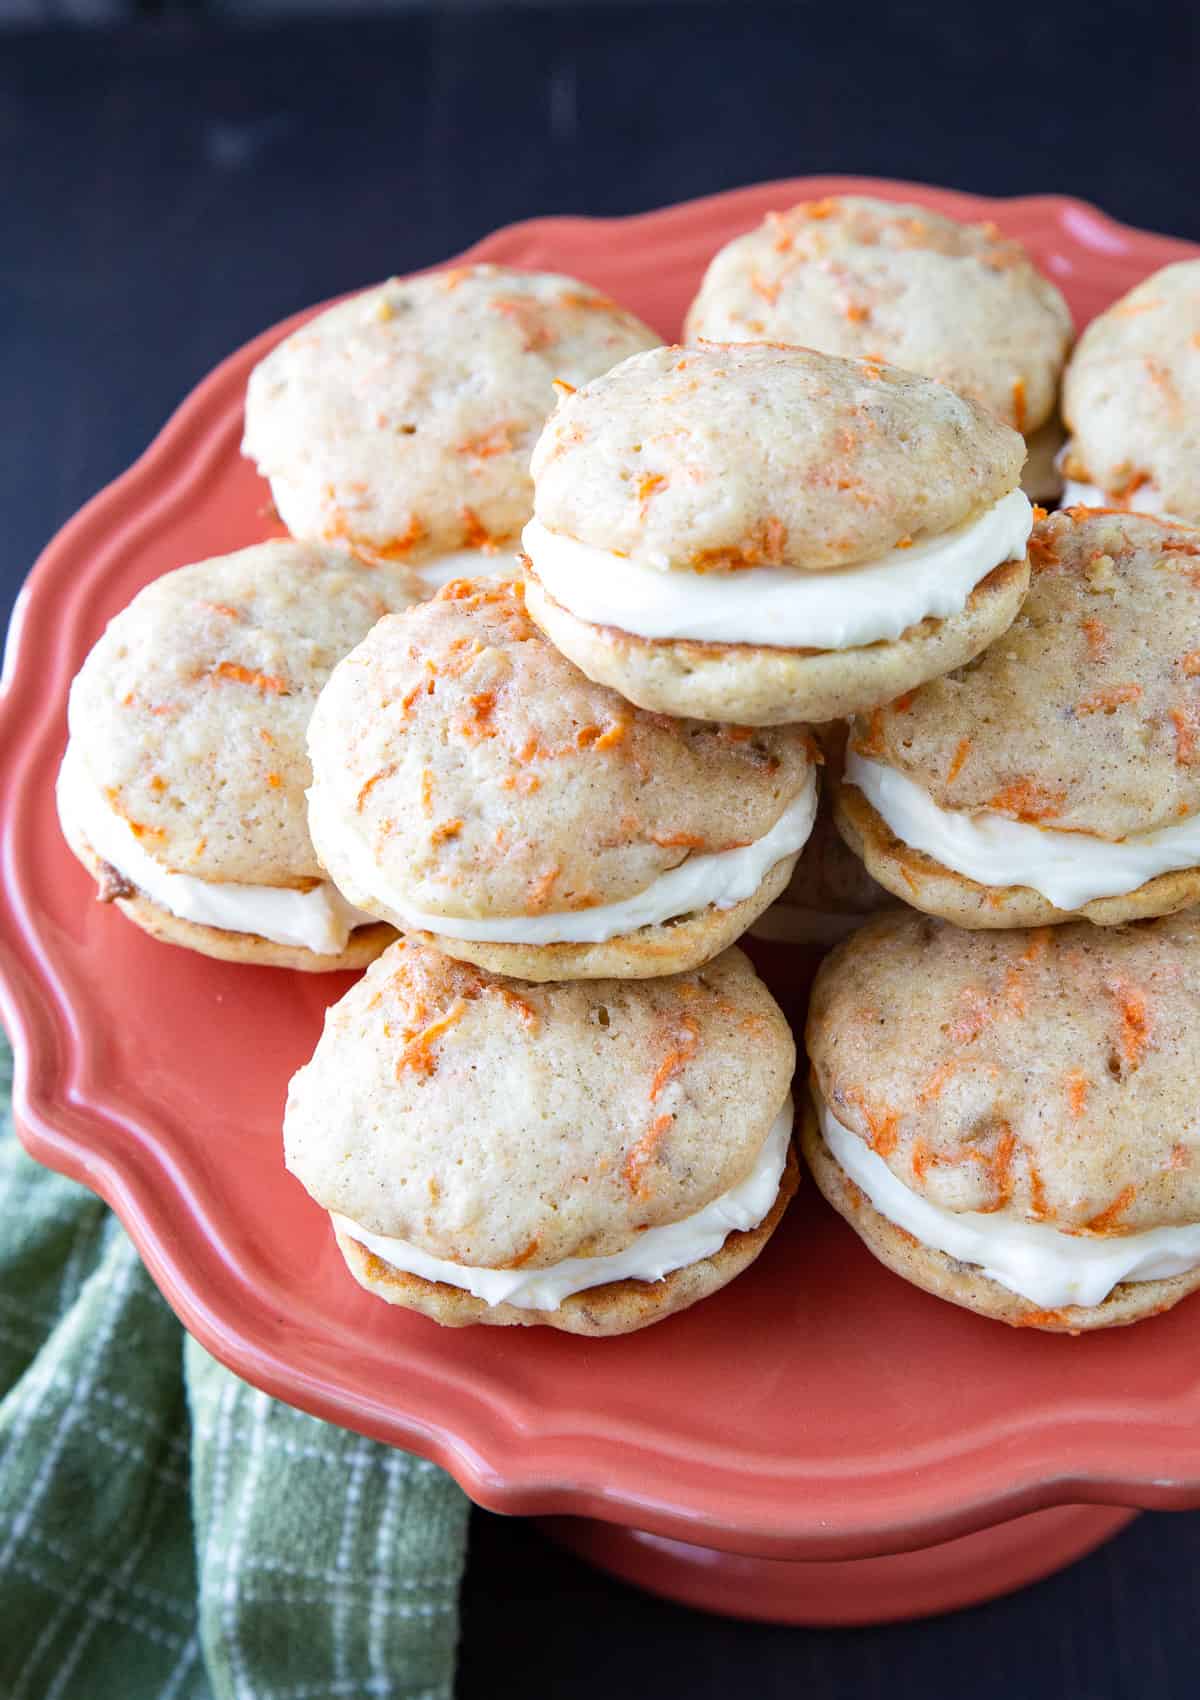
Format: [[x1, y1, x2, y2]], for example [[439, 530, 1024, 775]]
[[541, 1505, 1137, 1629]]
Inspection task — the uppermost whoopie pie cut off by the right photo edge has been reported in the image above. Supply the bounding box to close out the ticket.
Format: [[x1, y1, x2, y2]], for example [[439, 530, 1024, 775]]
[[1062, 260, 1200, 525]]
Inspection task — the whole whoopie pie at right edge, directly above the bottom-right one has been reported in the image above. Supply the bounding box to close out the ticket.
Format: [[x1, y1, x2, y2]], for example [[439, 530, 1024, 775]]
[[836, 508, 1200, 927]]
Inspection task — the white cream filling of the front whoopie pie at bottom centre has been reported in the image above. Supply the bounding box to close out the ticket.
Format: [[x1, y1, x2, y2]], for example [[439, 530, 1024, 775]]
[[330, 1098, 792, 1311]]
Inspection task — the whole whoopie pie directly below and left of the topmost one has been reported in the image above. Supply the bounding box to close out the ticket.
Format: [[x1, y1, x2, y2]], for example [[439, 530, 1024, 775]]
[[309, 580, 819, 981]]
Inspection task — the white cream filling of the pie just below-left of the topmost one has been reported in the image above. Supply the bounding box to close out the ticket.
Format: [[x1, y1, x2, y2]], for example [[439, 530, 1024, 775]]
[[308, 768, 818, 945]]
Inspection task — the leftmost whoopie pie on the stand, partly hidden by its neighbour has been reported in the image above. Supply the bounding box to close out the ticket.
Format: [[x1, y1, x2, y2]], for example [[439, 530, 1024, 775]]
[[58, 541, 420, 969]]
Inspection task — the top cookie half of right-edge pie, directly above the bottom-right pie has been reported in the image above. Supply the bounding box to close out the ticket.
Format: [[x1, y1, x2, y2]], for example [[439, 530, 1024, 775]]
[[852, 508, 1200, 840]]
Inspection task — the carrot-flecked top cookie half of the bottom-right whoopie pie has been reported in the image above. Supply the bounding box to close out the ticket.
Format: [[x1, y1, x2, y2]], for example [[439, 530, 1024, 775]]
[[807, 910, 1200, 1234]]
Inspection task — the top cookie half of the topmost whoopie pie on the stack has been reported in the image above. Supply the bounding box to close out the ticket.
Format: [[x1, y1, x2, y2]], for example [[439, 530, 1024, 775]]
[[532, 345, 1025, 571]]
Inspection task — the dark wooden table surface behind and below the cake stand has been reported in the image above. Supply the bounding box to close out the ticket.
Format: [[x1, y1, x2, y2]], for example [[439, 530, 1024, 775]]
[[0, 0, 1200, 1700]]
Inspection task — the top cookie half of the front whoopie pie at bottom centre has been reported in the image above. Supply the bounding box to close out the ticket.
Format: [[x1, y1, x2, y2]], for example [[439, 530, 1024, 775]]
[[284, 938, 795, 1268]]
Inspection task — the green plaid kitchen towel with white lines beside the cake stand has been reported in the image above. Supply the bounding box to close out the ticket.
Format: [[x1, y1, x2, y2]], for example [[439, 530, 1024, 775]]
[[0, 1035, 467, 1700]]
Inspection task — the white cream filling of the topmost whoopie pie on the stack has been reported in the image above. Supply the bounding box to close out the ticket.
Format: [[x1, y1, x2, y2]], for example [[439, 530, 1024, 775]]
[[522, 490, 1033, 649]]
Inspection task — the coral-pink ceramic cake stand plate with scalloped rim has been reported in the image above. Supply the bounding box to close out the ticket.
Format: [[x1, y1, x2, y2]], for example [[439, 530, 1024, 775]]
[[0, 179, 1200, 1561]]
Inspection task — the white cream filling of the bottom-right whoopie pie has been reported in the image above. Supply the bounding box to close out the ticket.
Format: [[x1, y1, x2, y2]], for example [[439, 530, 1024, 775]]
[[814, 1095, 1200, 1311]]
